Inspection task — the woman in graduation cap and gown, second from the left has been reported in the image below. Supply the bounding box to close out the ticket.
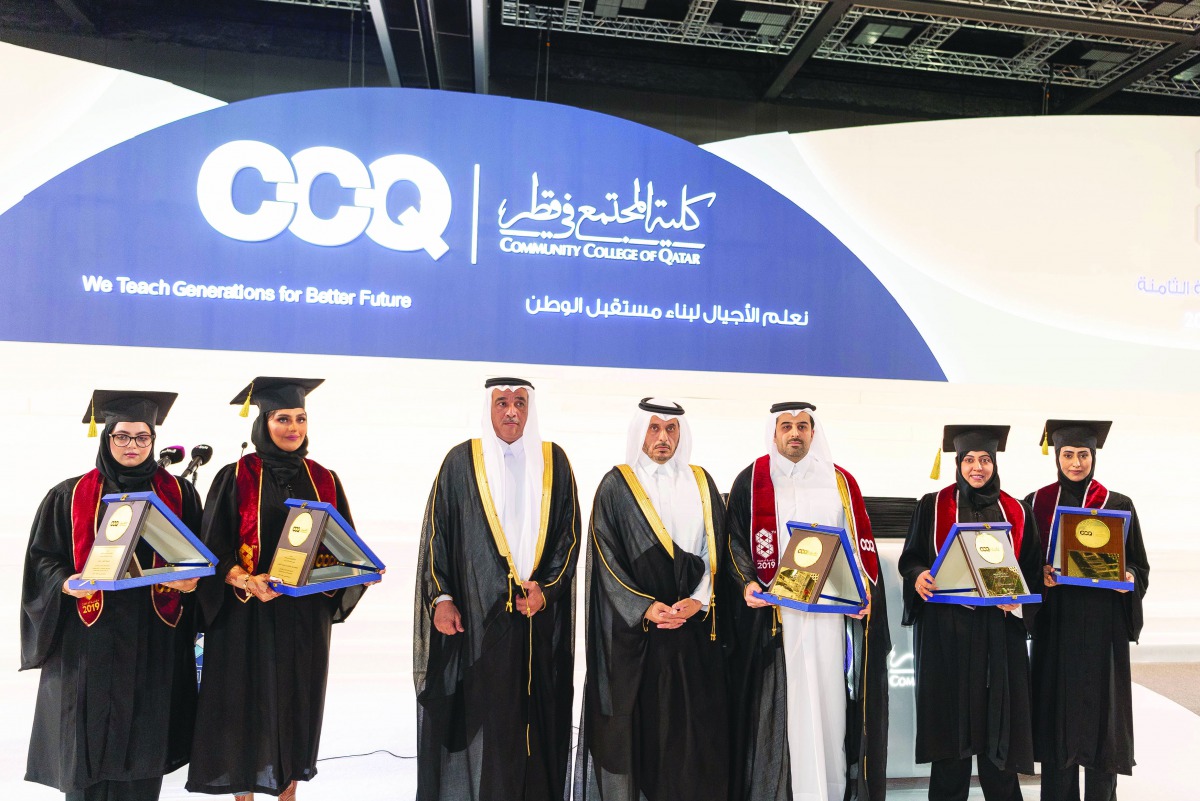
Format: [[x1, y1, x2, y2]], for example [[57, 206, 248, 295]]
[[187, 377, 364, 799]]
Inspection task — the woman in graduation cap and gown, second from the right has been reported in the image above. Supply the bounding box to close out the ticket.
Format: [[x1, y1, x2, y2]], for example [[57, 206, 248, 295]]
[[900, 426, 1042, 801]]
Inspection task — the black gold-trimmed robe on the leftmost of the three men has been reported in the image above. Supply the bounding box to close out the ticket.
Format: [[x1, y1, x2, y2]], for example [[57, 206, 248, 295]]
[[413, 440, 580, 801]]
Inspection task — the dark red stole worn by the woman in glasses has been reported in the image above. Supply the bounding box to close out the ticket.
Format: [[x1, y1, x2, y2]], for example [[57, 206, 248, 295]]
[[71, 468, 184, 628]]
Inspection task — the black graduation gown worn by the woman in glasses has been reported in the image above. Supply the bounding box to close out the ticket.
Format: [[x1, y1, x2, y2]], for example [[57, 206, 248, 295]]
[[20, 477, 200, 799]]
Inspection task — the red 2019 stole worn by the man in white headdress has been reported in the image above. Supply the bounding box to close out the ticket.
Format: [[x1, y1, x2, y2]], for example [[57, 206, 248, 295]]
[[750, 454, 880, 586]]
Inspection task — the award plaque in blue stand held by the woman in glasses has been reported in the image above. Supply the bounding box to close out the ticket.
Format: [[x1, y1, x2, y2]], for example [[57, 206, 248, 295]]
[[67, 493, 217, 590]]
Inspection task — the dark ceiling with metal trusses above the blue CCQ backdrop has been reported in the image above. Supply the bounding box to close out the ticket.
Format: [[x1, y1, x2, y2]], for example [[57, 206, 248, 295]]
[[7, 0, 1200, 119]]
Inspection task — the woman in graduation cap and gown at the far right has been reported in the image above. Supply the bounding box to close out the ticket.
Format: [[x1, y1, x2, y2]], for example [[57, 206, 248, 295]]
[[1025, 420, 1150, 801]]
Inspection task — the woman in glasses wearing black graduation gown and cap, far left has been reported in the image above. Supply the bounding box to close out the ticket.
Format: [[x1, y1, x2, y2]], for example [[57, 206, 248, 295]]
[[20, 391, 200, 801]]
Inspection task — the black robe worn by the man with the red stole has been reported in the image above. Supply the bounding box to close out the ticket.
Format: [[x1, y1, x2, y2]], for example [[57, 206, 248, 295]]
[[718, 464, 892, 801]]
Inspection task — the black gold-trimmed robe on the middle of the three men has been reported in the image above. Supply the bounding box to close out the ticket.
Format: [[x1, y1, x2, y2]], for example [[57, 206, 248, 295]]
[[575, 468, 730, 801]]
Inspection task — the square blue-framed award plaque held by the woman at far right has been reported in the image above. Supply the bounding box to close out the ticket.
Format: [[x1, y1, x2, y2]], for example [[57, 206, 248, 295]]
[[1049, 506, 1134, 590]]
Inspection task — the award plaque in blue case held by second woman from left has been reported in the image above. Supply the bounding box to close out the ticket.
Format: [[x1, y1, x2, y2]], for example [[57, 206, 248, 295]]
[[268, 498, 385, 596]]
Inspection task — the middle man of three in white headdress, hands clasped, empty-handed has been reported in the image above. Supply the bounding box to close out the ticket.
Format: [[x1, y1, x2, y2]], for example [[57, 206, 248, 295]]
[[575, 398, 728, 801]]
